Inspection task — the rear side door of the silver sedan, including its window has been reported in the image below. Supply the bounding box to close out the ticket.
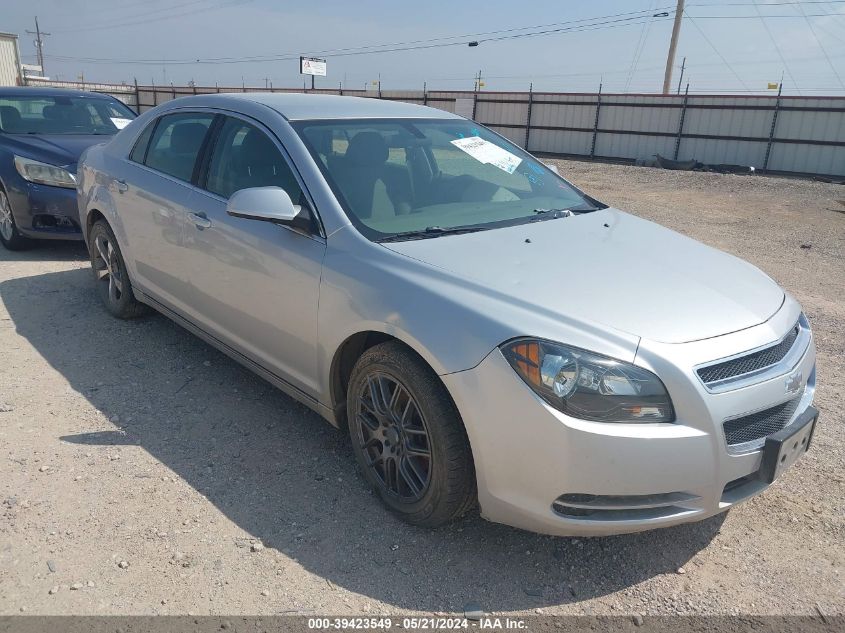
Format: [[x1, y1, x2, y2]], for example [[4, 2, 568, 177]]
[[121, 112, 215, 311]]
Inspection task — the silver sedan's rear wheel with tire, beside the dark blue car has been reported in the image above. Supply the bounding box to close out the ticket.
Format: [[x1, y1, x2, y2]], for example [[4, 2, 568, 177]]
[[88, 220, 149, 319]]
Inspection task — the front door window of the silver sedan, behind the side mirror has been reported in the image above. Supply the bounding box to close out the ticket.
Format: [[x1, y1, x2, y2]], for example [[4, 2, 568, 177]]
[[206, 117, 302, 204]]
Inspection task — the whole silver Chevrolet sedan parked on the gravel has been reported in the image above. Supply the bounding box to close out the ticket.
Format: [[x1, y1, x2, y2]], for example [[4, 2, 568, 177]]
[[77, 94, 818, 535]]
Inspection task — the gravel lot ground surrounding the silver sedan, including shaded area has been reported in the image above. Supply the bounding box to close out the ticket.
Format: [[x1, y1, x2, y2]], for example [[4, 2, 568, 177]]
[[0, 161, 845, 615]]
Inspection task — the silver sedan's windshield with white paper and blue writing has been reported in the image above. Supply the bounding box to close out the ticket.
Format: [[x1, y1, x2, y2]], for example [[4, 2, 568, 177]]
[[294, 119, 604, 240]]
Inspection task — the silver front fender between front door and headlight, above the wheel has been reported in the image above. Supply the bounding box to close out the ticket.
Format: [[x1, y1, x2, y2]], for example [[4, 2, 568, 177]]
[[318, 227, 639, 403]]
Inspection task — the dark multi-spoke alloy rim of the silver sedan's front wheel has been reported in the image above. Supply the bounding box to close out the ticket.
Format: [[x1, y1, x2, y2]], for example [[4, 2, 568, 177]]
[[355, 373, 432, 503]]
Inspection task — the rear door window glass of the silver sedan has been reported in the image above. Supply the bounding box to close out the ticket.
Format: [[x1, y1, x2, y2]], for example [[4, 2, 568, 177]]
[[145, 113, 214, 182]]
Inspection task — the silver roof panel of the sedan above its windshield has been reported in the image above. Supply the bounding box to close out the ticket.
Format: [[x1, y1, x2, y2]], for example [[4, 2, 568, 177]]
[[171, 92, 460, 121]]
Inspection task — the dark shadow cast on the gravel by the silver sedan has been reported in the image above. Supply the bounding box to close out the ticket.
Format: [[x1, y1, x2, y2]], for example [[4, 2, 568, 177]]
[[0, 269, 724, 611]]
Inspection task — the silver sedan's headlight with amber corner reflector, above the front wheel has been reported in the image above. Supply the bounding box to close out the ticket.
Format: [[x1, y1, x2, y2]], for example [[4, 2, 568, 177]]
[[501, 339, 675, 422]]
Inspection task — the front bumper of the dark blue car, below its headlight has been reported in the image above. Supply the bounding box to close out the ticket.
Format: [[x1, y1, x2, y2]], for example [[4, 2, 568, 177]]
[[8, 178, 82, 240]]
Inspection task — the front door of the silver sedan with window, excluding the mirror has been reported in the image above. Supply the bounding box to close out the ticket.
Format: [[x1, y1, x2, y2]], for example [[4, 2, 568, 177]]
[[185, 116, 326, 396]]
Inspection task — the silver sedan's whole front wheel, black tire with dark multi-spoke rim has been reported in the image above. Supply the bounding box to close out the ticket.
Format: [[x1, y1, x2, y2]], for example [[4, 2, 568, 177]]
[[346, 341, 476, 527]]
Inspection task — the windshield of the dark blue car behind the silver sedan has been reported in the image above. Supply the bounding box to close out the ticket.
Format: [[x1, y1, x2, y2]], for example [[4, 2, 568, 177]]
[[0, 95, 135, 134]]
